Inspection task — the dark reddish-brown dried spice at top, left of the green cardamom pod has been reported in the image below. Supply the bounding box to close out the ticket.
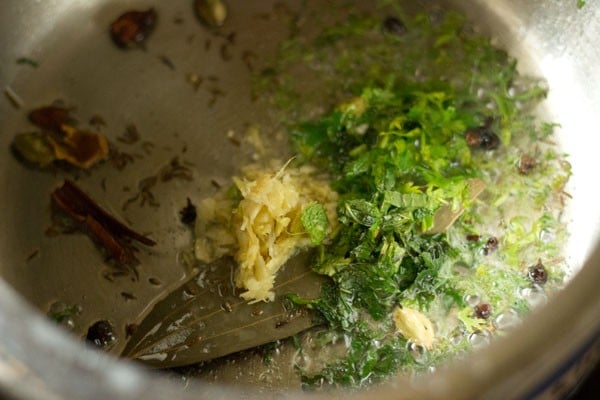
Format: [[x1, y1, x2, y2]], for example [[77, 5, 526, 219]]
[[110, 8, 157, 48]]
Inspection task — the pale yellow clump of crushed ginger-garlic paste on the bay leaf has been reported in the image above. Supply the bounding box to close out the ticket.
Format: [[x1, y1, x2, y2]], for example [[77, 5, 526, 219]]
[[195, 161, 338, 302]]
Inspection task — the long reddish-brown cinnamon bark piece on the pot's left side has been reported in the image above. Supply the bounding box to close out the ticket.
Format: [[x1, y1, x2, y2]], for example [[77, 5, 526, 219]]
[[52, 179, 156, 267]]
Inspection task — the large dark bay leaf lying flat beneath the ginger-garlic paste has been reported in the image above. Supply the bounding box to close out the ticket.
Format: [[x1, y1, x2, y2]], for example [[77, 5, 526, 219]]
[[122, 253, 326, 368]]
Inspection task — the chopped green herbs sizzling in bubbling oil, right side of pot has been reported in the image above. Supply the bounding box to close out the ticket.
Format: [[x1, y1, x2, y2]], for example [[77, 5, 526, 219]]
[[258, 5, 570, 386]]
